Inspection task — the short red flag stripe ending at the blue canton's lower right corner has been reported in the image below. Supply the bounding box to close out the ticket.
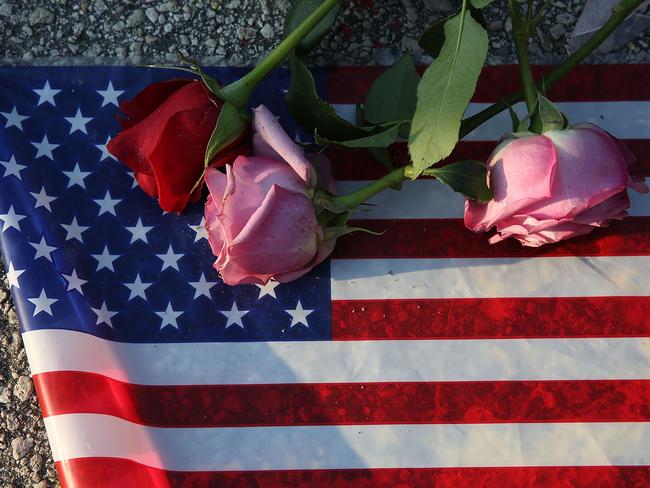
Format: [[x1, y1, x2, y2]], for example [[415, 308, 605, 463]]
[[332, 297, 650, 341]]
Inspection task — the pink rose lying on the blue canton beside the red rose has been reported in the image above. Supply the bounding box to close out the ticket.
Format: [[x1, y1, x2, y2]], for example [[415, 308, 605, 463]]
[[205, 106, 335, 285]]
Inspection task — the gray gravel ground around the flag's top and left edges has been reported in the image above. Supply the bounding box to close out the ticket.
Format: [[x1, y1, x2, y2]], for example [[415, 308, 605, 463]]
[[0, 0, 650, 488]]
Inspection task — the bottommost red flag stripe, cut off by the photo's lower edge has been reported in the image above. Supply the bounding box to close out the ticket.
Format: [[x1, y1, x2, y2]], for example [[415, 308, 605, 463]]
[[56, 460, 650, 488]]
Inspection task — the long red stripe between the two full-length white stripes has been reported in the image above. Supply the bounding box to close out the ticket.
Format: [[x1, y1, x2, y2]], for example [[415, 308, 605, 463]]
[[34, 372, 650, 427]]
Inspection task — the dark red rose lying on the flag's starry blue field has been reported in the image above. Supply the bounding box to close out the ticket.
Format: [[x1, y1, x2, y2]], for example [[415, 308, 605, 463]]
[[108, 79, 248, 212]]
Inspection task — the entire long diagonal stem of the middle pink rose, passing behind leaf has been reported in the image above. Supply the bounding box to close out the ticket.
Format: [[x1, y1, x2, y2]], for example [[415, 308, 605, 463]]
[[337, 0, 644, 208]]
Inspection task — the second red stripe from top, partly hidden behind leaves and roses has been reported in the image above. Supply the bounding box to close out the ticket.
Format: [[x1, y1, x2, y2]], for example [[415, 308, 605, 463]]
[[329, 139, 650, 180]]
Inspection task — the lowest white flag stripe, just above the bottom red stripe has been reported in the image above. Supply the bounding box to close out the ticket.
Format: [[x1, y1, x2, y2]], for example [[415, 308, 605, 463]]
[[45, 414, 650, 471]]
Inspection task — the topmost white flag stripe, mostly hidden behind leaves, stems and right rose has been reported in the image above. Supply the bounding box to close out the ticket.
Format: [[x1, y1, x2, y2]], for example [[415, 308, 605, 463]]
[[334, 101, 650, 141]]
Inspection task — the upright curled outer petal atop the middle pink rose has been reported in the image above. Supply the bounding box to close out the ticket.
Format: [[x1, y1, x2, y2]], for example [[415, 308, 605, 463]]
[[253, 105, 312, 185]]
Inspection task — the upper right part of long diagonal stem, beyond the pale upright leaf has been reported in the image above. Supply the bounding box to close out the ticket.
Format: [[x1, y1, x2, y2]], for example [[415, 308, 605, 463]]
[[460, 0, 644, 137]]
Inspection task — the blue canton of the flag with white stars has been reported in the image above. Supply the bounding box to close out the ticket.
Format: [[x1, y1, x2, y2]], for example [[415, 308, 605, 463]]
[[0, 67, 331, 342]]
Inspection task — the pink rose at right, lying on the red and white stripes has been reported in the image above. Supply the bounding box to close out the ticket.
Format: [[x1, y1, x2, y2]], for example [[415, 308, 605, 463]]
[[465, 124, 648, 247]]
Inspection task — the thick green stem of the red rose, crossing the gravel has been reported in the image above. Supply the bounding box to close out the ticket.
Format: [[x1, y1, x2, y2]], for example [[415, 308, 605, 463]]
[[221, 0, 340, 108]]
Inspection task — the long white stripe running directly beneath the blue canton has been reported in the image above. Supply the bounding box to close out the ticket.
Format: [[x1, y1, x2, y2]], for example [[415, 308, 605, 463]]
[[23, 330, 650, 385]]
